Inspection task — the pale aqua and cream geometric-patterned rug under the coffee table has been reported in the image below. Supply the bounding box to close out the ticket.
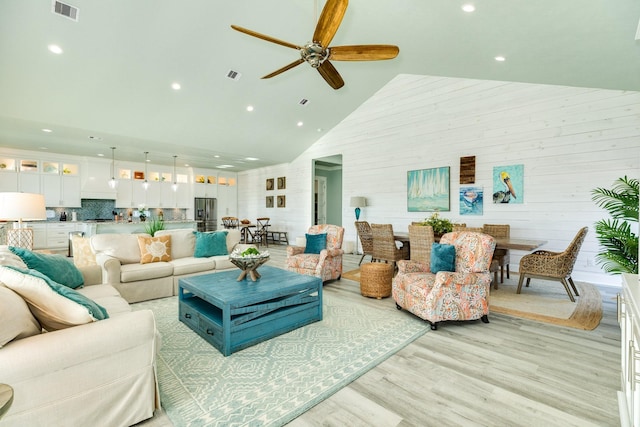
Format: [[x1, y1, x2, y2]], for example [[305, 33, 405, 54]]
[[133, 292, 428, 427]]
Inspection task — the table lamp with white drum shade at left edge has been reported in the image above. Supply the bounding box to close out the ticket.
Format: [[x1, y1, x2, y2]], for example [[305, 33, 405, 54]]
[[0, 193, 47, 250]]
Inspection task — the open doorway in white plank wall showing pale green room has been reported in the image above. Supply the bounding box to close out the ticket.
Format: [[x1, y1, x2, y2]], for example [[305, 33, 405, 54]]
[[312, 155, 342, 226]]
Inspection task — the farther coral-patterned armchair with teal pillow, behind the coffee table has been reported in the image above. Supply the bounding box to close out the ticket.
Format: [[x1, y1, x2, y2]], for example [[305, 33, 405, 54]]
[[285, 224, 344, 283]]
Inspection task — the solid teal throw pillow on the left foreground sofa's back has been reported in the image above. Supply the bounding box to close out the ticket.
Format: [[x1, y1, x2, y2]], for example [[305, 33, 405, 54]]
[[9, 246, 84, 289]]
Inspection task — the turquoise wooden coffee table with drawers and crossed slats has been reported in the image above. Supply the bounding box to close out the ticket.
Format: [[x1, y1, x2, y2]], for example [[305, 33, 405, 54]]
[[178, 265, 322, 356]]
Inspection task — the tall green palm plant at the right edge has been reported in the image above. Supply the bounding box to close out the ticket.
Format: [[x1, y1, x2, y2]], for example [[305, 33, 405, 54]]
[[591, 175, 639, 274]]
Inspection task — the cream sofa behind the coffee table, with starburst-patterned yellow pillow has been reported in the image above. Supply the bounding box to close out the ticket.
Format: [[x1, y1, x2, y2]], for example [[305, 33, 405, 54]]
[[91, 229, 250, 303]]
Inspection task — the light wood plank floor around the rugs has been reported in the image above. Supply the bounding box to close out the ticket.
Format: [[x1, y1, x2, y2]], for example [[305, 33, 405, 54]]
[[142, 246, 620, 427]]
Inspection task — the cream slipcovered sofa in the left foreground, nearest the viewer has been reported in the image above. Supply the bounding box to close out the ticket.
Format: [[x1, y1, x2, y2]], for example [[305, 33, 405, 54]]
[[0, 247, 160, 427]]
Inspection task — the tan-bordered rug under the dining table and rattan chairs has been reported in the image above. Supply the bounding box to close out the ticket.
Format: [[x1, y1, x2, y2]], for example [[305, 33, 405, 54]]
[[342, 269, 602, 331]]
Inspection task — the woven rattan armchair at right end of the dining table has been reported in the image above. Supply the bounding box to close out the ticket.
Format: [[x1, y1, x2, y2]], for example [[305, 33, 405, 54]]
[[517, 227, 588, 302]]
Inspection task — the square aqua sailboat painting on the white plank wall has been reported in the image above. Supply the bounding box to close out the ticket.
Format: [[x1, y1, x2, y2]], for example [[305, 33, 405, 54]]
[[407, 166, 451, 212]]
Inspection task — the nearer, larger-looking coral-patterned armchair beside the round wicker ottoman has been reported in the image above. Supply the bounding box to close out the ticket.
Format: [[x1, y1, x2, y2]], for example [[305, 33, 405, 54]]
[[392, 231, 496, 330]]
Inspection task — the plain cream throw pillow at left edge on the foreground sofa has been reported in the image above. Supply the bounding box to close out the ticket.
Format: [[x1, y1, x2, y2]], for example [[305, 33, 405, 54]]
[[0, 283, 42, 348]]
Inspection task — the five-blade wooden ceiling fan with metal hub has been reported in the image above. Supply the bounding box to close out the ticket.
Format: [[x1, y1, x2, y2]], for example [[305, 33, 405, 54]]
[[231, 0, 400, 89]]
